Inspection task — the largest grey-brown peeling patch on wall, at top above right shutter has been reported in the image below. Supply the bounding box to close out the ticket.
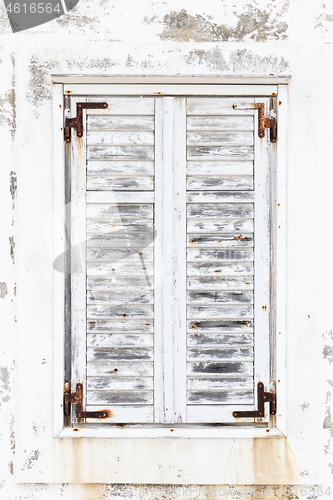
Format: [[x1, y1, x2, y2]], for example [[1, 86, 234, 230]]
[[154, 1, 289, 42]]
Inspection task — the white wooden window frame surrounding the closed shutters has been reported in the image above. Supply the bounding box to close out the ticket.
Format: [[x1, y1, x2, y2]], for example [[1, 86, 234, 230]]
[[53, 75, 290, 438]]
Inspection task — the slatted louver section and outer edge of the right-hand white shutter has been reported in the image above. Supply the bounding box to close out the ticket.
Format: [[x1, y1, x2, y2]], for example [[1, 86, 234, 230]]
[[187, 98, 269, 423]]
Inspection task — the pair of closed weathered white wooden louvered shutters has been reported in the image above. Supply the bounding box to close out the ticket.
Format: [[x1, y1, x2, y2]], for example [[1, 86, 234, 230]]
[[68, 92, 271, 424]]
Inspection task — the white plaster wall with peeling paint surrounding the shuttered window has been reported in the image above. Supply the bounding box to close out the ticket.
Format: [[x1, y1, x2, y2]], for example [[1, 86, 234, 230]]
[[0, 0, 333, 500]]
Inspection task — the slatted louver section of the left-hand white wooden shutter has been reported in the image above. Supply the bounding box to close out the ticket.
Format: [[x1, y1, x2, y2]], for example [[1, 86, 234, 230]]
[[73, 94, 155, 423]]
